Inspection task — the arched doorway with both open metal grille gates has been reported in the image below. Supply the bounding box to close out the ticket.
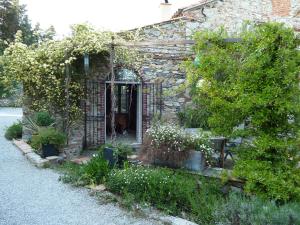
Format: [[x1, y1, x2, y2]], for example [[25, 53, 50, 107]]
[[84, 68, 163, 148]]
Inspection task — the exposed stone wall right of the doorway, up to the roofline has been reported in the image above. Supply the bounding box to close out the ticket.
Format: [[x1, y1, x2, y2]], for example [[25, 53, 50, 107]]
[[134, 0, 300, 122]]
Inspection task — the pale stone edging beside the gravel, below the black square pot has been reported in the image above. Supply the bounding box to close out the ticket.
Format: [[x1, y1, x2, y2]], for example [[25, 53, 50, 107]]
[[12, 139, 61, 168]]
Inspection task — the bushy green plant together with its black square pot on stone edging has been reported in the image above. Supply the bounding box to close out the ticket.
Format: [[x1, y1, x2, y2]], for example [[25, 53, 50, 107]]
[[31, 127, 66, 158]]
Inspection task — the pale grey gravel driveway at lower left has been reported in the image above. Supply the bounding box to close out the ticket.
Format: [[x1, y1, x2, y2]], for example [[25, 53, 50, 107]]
[[0, 108, 161, 225]]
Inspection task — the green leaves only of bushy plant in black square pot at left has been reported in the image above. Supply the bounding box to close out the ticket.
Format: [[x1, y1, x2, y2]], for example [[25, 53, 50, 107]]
[[31, 127, 66, 151]]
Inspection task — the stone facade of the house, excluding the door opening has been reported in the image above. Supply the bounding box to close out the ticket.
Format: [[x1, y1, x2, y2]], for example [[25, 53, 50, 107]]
[[21, 0, 300, 158]]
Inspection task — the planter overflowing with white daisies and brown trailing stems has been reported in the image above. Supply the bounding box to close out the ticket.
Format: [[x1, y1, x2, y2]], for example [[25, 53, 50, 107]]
[[141, 123, 213, 171]]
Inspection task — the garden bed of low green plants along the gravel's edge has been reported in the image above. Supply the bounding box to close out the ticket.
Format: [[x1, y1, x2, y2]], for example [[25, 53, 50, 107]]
[[55, 149, 300, 225]]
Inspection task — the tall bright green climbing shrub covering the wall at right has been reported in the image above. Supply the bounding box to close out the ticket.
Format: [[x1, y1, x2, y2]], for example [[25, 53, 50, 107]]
[[186, 23, 300, 201]]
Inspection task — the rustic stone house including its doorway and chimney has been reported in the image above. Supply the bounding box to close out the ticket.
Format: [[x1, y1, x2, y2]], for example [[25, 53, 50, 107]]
[[39, 0, 300, 157]]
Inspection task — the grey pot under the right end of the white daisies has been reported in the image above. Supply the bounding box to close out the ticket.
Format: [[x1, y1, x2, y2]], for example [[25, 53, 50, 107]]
[[183, 150, 205, 171]]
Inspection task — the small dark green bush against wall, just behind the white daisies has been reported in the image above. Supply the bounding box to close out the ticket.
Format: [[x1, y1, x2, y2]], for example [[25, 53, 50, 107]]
[[178, 105, 210, 130]]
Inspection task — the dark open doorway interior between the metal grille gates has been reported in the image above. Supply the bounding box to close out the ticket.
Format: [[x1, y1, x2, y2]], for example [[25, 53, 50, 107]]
[[106, 82, 140, 144]]
